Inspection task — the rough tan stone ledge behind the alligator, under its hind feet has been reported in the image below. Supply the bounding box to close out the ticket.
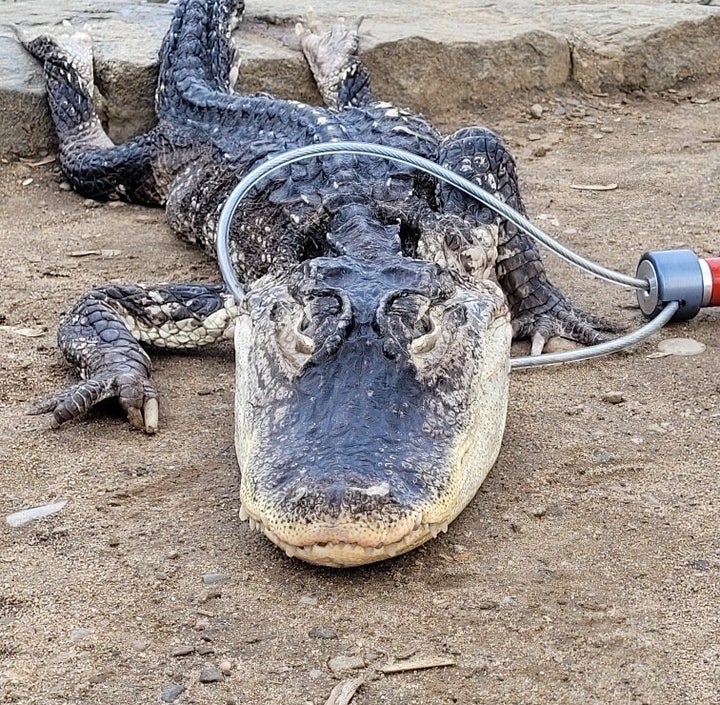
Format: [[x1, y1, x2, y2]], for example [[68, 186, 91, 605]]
[[0, 0, 720, 155]]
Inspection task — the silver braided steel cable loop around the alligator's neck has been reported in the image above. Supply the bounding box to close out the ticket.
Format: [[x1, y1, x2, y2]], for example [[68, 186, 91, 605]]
[[215, 142, 668, 369]]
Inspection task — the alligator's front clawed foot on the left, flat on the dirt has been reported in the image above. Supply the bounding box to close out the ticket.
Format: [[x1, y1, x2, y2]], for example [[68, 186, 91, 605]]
[[27, 373, 158, 433]]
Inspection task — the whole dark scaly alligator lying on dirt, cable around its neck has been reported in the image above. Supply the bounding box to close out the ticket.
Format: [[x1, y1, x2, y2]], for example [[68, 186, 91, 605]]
[[21, 0, 614, 567]]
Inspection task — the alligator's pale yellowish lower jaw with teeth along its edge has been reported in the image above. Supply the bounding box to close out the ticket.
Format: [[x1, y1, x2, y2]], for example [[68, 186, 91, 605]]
[[240, 507, 449, 568]]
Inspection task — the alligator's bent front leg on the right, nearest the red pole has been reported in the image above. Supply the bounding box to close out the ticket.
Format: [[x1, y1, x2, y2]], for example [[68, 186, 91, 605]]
[[438, 127, 620, 355]]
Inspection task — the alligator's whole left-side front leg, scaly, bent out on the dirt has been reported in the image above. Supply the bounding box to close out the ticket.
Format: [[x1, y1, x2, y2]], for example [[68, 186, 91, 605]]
[[29, 284, 237, 433]]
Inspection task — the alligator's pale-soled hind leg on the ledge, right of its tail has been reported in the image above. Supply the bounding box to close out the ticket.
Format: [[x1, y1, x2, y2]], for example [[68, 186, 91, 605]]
[[296, 15, 373, 108]]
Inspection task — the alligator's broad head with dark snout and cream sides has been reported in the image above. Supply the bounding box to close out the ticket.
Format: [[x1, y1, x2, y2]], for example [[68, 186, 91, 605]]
[[235, 248, 511, 566]]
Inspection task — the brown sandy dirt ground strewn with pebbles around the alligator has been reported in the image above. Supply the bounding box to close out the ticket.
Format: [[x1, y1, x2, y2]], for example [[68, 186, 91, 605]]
[[0, 74, 720, 705]]
